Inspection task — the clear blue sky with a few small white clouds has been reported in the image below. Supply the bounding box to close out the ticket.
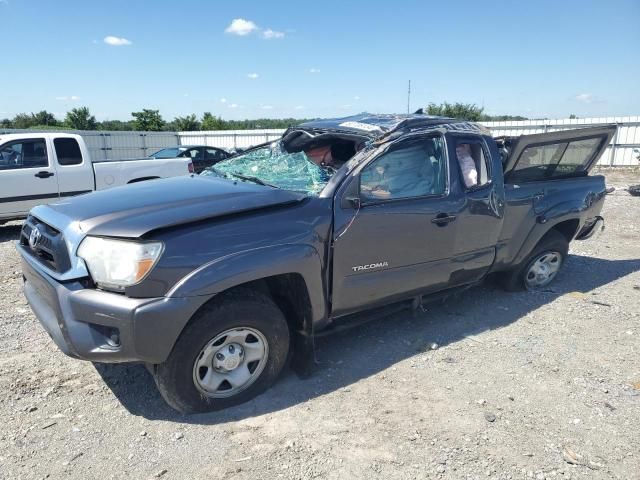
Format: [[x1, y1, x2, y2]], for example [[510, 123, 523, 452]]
[[0, 0, 640, 120]]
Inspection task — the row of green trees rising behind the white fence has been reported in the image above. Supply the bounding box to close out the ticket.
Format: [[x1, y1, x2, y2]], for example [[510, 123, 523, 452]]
[[0, 102, 528, 132]]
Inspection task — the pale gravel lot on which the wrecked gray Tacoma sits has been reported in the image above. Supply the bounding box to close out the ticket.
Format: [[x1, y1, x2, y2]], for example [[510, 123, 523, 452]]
[[0, 174, 640, 480]]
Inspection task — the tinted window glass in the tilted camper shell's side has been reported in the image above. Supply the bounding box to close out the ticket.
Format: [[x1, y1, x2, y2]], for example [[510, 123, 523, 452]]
[[509, 137, 602, 183]]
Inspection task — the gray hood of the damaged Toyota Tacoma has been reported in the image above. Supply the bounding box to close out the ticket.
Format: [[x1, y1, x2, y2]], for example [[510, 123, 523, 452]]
[[41, 176, 306, 238]]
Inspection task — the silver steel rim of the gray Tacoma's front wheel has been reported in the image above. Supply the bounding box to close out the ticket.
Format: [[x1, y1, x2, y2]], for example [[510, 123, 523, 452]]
[[193, 327, 269, 398]]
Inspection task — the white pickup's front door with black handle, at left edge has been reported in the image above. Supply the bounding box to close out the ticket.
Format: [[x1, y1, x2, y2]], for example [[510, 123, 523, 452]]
[[0, 138, 58, 218]]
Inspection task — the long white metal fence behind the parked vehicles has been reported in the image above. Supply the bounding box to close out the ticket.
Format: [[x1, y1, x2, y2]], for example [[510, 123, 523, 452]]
[[0, 116, 640, 166]]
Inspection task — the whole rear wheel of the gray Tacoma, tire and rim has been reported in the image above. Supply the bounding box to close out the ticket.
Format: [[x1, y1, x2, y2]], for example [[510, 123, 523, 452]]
[[502, 230, 569, 291]]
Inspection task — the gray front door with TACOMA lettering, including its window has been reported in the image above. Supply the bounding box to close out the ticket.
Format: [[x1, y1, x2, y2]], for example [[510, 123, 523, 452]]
[[332, 135, 465, 316]]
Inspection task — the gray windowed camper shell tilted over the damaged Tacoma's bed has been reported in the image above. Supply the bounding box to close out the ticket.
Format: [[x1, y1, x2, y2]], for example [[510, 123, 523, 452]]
[[504, 125, 616, 183]]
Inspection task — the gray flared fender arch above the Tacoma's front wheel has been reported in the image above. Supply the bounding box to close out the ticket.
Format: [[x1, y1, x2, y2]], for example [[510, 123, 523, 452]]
[[166, 244, 326, 323]]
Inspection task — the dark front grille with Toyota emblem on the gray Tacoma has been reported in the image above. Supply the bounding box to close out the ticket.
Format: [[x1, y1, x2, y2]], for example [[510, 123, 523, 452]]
[[20, 216, 71, 273]]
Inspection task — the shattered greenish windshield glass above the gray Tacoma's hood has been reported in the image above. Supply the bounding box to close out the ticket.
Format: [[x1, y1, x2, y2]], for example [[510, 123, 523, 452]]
[[201, 141, 335, 196]]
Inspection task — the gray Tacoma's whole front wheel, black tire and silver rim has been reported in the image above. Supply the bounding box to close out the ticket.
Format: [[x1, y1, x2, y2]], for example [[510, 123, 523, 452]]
[[154, 289, 290, 413]]
